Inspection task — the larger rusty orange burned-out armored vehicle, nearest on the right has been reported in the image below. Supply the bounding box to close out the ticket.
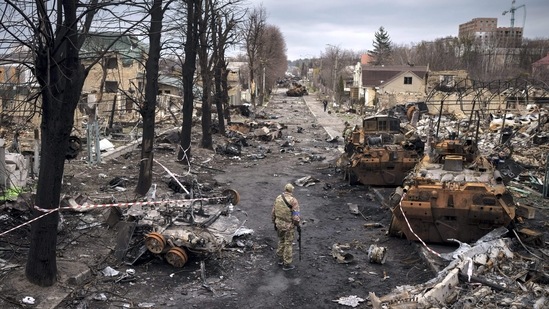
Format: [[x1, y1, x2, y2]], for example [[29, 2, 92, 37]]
[[389, 134, 515, 243]]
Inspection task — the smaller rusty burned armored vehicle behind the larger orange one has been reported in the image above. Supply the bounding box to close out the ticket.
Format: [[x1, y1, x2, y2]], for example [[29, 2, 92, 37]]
[[339, 115, 424, 186]]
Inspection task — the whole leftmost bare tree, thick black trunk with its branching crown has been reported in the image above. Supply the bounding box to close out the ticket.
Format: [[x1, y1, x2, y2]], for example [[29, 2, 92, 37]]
[[0, 0, 148, 286]]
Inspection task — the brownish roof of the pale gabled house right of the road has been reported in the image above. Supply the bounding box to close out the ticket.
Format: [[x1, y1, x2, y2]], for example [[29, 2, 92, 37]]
[[362, 65, 428, 87]]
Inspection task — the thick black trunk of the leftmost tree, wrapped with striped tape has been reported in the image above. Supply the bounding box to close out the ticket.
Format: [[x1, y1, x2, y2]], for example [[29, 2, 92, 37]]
[[25, 1, 85, 286]]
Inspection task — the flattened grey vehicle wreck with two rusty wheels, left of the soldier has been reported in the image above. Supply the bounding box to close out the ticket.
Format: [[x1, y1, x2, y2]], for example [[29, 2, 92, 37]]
[[116, 186, 241, 267]]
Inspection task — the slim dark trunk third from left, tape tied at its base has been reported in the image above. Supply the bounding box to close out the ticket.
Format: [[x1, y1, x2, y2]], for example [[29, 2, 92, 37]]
[[177, 0, 201, 162]]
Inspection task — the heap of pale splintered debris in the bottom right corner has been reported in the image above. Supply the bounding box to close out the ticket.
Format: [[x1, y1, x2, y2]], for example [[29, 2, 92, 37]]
[[369, 238, 549, 309]]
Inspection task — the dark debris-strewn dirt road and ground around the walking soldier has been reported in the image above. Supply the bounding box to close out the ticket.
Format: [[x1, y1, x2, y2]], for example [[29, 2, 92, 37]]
[[0, 91, 544, 309]]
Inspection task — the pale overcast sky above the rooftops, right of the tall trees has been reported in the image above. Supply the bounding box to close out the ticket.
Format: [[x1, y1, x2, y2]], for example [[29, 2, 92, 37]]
[[248, 0, 549, 60]]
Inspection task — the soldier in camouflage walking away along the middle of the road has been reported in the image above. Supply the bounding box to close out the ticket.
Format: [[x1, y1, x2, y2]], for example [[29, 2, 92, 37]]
[[271, 184, 300, 270]]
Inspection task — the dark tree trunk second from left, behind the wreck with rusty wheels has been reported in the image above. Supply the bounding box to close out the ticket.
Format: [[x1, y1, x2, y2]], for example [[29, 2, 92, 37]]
[[135, 0, 164, 196]]
